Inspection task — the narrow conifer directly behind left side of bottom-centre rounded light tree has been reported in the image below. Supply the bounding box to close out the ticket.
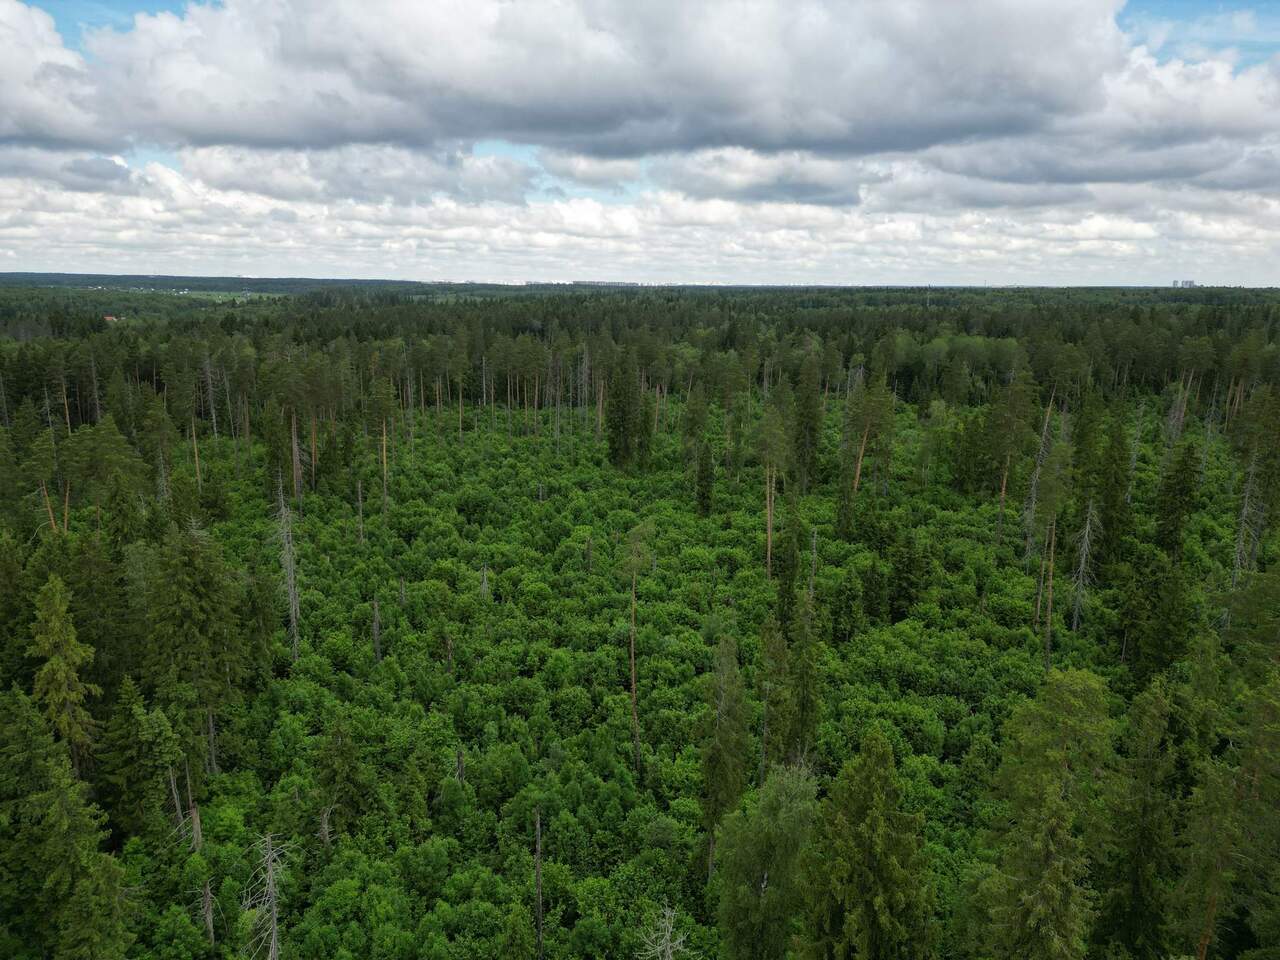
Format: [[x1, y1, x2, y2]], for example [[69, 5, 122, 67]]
[[703, 634, 746, 876]]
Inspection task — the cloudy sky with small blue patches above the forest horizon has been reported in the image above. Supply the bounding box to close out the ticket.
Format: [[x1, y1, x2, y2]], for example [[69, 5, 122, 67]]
[[0, 0, 1280, 285]]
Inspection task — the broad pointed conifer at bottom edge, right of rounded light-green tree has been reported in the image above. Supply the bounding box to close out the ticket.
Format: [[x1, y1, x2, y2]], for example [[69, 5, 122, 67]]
[[805, 728, 929, 960]]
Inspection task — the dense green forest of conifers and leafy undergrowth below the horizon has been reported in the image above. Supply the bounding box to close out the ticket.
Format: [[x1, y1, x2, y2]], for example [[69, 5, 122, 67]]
[[0, 284, 1280, 960]]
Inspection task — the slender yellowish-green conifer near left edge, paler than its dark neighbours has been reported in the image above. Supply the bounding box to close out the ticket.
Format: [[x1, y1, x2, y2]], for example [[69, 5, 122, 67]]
[[29, 575, 102, 777]]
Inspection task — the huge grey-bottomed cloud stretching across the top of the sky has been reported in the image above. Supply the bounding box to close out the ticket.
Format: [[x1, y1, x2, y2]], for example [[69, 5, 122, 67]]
[[70, 0, 1124, 156]]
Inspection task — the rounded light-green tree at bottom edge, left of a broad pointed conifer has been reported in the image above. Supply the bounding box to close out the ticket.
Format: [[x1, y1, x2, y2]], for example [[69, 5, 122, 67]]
[[718, 767, 818, 960]]
